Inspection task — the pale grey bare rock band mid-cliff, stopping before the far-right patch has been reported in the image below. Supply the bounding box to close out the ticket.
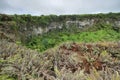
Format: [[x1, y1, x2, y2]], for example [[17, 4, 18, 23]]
[[32, 19, 94, 35]]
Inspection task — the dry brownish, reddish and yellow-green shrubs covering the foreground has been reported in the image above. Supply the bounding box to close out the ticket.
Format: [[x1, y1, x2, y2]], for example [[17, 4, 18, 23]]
[[0, 40, 120, 80]]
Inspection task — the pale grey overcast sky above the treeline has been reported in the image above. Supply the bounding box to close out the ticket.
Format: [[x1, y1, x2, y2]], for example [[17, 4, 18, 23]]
[[0, 0, 120, 15]]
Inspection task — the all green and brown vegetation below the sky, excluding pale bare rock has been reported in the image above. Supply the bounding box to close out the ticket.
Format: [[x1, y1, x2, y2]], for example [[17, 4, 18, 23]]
[[0, 13, 120, 80]]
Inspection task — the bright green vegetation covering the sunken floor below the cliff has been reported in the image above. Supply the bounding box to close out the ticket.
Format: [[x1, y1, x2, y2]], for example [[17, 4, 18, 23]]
[[26, 29, 120, 52]]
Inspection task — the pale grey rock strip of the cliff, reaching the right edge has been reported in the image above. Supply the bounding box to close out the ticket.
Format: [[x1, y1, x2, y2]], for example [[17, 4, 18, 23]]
[[25, 19, 120, 35]]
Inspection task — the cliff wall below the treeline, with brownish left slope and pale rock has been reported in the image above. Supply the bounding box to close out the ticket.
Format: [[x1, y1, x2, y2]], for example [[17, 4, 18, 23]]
[[0, 16, 120, 39]]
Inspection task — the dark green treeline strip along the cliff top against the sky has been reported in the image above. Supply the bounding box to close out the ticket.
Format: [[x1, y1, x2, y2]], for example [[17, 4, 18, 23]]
[[0, 13, 120, 28]]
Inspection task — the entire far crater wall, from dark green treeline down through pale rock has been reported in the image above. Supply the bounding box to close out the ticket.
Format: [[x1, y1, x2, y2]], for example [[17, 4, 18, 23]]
[[0, 13, 120, 39]]
